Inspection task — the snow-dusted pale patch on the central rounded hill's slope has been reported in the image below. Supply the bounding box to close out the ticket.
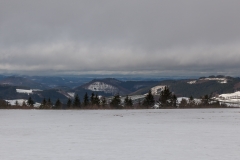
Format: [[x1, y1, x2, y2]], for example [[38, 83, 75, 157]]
[[85, 82, 119, 94]]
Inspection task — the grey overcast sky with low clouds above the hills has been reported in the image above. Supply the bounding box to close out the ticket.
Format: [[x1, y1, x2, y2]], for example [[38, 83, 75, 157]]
[[0, 0, 240, 76]]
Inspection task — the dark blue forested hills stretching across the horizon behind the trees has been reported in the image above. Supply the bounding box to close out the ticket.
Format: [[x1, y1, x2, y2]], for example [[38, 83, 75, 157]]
[[0, 76, 240, 103]]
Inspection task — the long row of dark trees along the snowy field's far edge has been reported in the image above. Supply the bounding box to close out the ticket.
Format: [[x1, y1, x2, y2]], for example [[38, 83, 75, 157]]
[[0, 86, 227, 109]]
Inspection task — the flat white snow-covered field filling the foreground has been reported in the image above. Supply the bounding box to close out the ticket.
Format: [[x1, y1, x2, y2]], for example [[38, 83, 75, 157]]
[[0, 109, 240, 160]]
